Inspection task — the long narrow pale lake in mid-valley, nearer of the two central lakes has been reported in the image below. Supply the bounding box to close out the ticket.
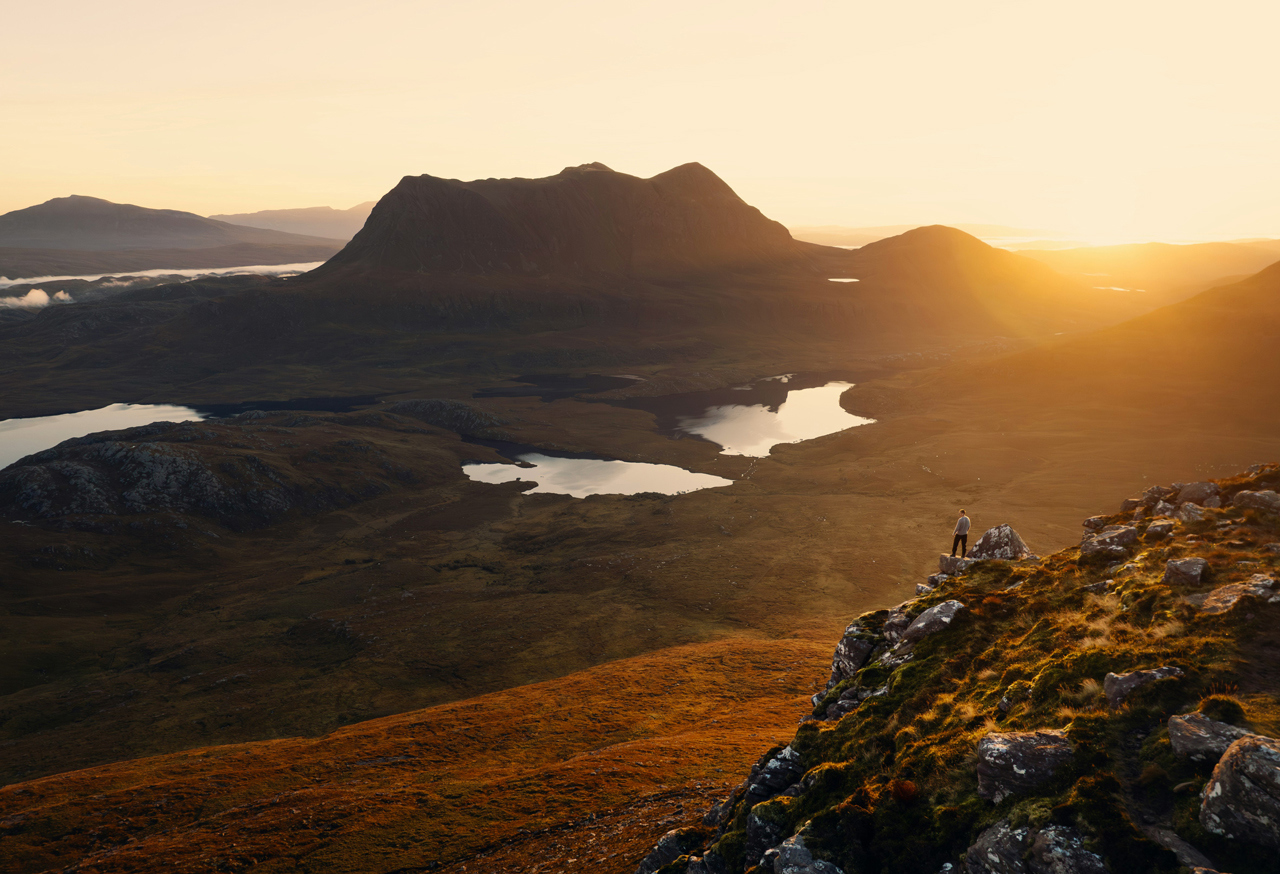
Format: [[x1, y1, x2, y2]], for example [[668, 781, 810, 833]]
[[462, 452, 733, 498]]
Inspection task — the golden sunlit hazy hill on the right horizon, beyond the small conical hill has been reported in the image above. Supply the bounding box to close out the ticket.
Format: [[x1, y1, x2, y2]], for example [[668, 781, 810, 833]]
[[1019, 241, 1280, 302]]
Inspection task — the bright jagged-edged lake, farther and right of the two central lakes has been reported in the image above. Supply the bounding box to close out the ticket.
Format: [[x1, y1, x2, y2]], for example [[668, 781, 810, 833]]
[[680, 383, 876, 458]]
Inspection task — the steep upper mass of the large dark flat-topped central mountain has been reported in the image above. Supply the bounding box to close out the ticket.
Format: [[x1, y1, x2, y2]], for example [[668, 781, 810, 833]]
[[317, 164, 805, 275]]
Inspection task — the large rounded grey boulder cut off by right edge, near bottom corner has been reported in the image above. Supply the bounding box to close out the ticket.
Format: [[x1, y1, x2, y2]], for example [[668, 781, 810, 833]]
[[1199, 735, 1280, 850]]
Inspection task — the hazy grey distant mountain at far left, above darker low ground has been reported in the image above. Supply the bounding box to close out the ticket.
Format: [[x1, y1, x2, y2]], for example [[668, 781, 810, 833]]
[[0, 195, 343, 251]]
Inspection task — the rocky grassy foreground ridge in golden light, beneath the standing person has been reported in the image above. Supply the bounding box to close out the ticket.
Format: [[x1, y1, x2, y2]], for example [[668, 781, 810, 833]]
[[637, 465, 1280, 874]]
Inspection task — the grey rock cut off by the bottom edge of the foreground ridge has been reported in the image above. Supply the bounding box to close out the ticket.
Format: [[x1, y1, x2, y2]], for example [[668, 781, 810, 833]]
[[964, 819, 1106, 874]]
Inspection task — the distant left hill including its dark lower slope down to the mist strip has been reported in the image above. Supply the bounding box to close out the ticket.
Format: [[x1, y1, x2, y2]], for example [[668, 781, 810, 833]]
[[0, 196, 342, 279]]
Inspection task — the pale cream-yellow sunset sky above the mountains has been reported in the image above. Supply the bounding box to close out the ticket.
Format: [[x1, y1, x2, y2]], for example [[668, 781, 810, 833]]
[[0, 0, 1280, 242]]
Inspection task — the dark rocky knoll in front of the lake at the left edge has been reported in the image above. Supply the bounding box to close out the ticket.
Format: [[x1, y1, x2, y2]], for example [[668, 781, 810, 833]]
[[0, 402, 461, 532]]
